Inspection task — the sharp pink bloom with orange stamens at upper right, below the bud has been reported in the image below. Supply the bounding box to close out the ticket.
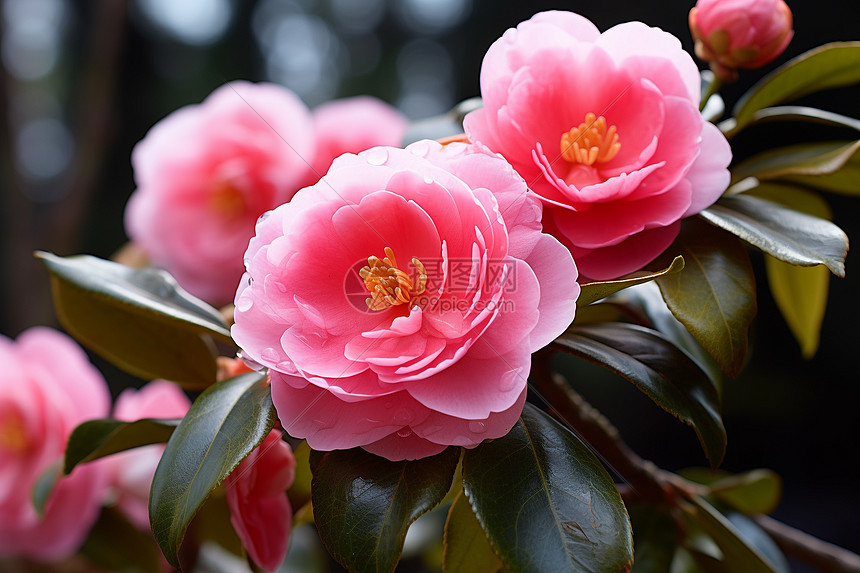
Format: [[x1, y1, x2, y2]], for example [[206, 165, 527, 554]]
[[465, 12, 731, 279]]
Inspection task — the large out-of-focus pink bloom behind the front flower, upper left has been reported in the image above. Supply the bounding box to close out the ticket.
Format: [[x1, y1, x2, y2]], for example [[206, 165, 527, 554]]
[[125, 81, 314, 304]]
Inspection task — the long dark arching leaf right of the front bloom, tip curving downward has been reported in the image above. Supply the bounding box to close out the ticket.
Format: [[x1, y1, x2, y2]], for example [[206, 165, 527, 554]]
[[553, 322, 726, 467]]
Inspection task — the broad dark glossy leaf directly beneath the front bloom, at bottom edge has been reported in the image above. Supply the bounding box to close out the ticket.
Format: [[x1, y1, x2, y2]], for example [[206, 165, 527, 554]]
[[463, 403, 633, 573]]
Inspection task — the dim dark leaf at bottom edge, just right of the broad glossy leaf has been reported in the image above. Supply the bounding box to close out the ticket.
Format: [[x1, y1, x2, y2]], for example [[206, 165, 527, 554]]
[[629, 505, 680, 573]]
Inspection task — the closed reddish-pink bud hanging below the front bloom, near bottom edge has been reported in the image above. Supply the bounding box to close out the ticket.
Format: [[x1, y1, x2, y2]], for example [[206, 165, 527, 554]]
[[224, 430, 296, 571]]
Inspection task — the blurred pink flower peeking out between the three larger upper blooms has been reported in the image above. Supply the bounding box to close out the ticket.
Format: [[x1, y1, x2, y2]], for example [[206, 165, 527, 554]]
[[313, 96, 409, 179]]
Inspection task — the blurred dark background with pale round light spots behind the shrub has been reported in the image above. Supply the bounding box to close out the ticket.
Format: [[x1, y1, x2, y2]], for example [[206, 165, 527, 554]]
[[0, 0, 860, 571]]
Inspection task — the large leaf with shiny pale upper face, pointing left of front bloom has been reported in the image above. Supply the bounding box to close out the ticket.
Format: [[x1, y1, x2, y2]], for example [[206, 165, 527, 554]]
[[37, 252, 232, 388]]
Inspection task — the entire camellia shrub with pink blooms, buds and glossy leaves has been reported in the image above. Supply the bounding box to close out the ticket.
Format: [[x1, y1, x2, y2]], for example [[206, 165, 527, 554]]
[[6, 0, 860, 573]]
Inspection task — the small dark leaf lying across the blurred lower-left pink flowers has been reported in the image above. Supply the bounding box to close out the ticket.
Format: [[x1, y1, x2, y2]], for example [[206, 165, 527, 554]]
[[63, 418, 180, 475]]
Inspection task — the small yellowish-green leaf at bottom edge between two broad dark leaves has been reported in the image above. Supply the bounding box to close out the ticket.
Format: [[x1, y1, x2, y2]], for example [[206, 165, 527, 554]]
[[442, 492, 502, 573]]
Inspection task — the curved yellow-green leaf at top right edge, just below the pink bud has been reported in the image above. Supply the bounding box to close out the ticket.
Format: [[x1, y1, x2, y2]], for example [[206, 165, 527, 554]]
[[734, 42, 860, 132]]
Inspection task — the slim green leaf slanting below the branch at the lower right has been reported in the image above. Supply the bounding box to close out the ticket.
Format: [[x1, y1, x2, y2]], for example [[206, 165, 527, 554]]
[[681, 496, 779, 573]]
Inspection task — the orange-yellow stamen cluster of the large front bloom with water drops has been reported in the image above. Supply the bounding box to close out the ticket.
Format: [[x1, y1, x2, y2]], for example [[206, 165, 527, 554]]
[[358, 247, 427, 310]]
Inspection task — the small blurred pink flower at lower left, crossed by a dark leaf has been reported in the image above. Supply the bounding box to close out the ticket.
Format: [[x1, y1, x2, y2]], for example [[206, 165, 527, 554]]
[[106, 380, 191, 531]]
